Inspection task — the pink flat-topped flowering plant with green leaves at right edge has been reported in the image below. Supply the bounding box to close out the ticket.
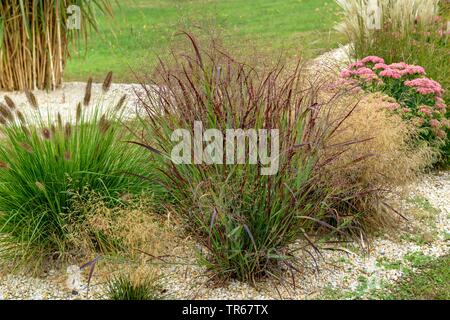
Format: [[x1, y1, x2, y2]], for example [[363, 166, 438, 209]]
[[340, 56, 450, 162]]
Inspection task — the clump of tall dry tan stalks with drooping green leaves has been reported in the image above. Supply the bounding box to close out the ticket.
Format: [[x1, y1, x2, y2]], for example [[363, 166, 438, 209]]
[[0, 0, 111, 90]]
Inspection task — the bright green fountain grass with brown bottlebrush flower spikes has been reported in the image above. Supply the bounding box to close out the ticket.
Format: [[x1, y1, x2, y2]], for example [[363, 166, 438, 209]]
[[0, 74, 147, 263]]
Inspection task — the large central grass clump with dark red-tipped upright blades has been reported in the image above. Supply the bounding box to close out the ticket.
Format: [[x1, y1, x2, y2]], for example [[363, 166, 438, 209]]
[[134, 35, 384, 282]]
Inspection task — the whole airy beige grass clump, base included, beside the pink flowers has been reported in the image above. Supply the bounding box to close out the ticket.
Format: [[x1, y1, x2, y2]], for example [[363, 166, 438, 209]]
[[314, 86, 435, 237]]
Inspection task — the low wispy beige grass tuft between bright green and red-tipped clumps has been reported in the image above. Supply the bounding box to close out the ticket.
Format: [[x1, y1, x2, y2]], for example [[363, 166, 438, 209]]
[[67, 195, 174, 260]]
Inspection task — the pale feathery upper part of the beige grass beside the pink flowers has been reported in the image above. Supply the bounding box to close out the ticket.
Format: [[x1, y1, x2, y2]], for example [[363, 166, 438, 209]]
[[330, 93, 434, 186]]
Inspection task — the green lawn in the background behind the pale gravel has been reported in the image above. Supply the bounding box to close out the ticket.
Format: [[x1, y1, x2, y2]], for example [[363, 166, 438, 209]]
[[65, 0, 342, 82]]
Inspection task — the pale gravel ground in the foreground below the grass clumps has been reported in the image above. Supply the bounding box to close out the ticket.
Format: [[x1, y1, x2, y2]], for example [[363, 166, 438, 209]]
[[0, 172, 450, 299]]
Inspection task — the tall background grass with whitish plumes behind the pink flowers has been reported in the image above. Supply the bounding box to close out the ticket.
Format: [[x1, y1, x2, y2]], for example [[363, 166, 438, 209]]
[[337, 0, 444, 102]]
